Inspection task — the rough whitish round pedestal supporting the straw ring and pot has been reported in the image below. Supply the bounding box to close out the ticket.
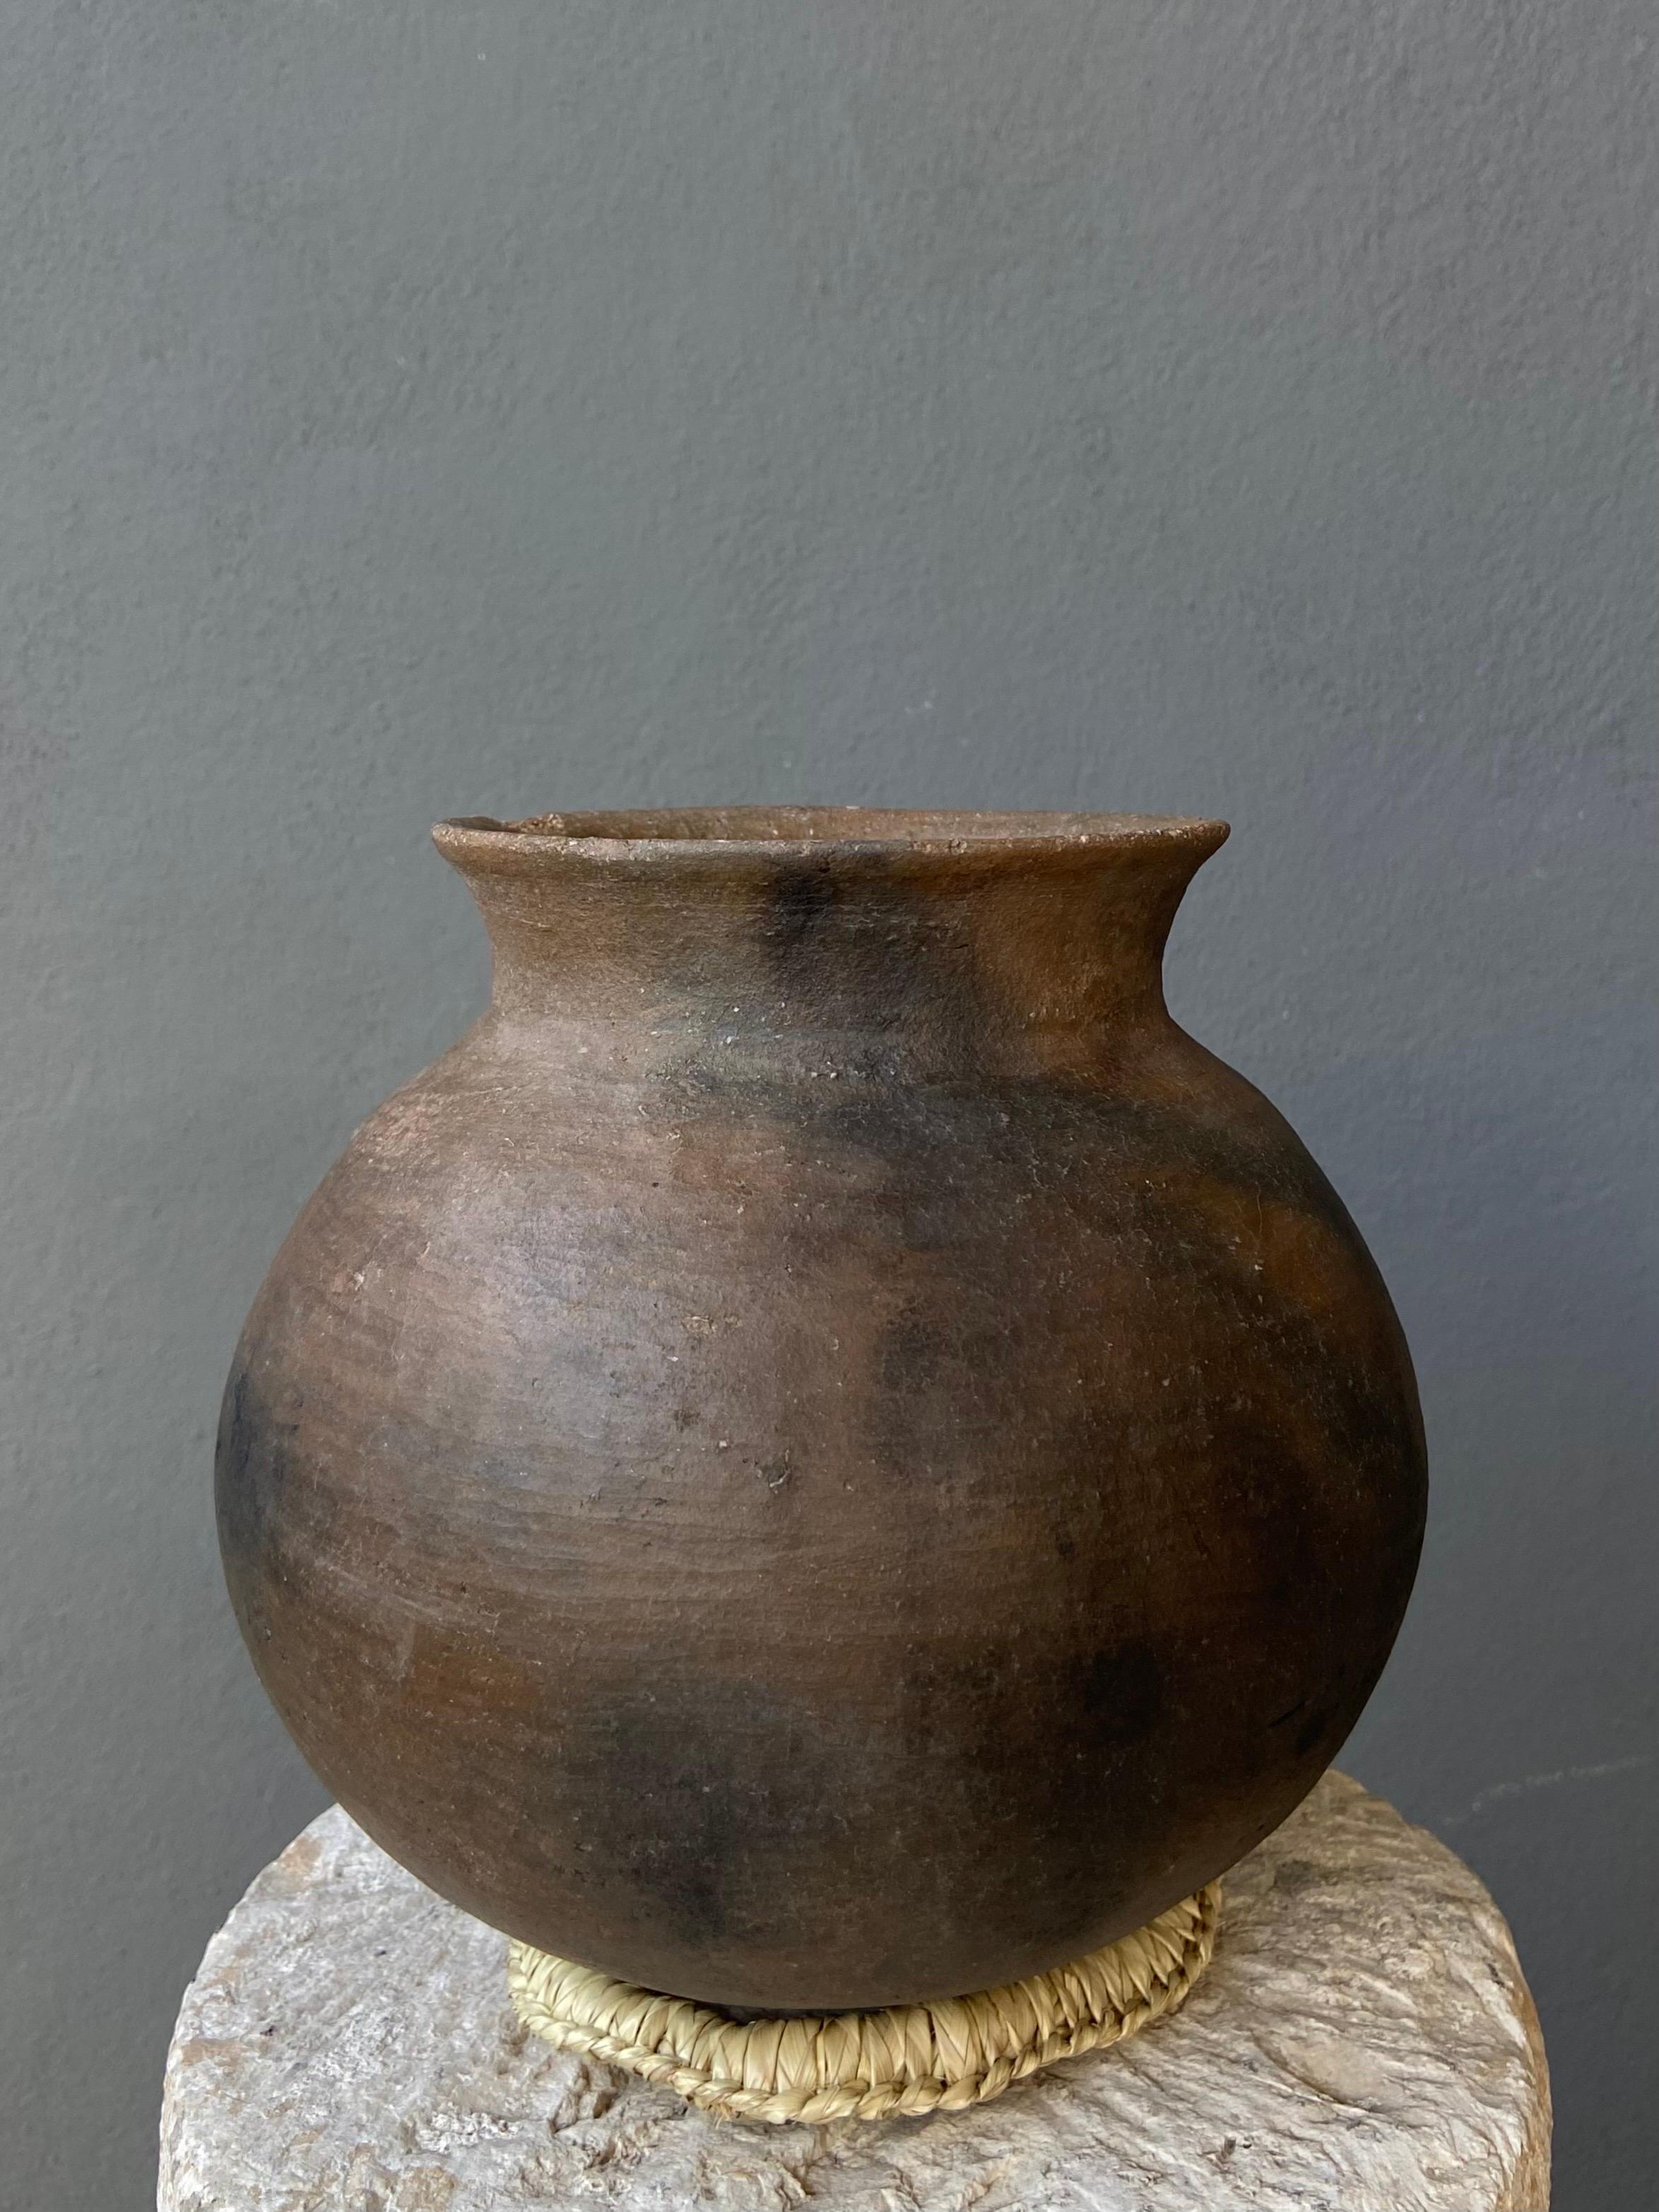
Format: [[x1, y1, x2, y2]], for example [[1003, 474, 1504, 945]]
[[159, 1774, 1548, 2212]]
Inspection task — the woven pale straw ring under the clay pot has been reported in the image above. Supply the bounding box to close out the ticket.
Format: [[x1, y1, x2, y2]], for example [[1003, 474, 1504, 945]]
[[507, 1882, 1221, 2122]]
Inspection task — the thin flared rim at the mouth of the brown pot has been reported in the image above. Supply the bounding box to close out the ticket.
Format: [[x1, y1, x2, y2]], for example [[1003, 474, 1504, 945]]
[[431, 805, 1228, 869]]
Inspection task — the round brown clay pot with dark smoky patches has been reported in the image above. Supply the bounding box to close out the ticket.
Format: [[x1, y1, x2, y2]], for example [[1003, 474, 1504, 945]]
[[219, 808, 1424, 2009]]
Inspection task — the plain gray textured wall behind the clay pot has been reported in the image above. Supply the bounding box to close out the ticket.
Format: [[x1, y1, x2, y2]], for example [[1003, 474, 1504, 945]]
[[0, 0, 1659, 2212]]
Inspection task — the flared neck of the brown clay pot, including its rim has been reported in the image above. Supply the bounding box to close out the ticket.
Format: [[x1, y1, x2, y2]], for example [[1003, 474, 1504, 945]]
[[434, 810, 1225, 1064]]
